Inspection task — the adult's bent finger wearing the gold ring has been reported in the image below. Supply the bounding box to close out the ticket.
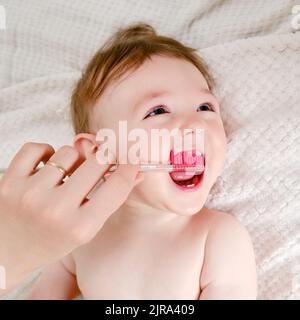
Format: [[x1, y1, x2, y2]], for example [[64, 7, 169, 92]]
[[33, 145, 82, 187]]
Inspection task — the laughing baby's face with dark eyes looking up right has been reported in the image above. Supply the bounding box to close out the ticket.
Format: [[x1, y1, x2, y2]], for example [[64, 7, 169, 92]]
[[91, 56, 226, 215]]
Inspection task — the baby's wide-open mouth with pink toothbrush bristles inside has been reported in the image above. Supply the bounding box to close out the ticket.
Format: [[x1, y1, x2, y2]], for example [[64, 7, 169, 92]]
[[170, 149, 205, 190]]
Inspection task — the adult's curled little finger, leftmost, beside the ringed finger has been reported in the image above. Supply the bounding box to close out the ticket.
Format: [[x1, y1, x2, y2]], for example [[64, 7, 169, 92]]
[[5, 142, 55, 177]]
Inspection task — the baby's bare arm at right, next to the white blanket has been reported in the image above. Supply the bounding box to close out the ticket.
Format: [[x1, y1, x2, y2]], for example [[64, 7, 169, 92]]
[[200, 213, 257, 300]]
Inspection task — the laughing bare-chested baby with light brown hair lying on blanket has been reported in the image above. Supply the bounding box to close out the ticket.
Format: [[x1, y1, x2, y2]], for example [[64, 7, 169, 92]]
[[27, 23, 257, 300]]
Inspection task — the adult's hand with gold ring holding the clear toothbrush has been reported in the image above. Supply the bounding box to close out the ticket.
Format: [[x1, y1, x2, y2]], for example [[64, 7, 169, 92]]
[[0, 143, 143, 291]]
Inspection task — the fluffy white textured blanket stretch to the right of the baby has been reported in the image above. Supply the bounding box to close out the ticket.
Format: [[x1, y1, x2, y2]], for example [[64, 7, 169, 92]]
[[202, 33, 300, 299]]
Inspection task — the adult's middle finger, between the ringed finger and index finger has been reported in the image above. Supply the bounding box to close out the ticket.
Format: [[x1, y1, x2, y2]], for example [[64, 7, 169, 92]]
[[61, 153, 115, 206]]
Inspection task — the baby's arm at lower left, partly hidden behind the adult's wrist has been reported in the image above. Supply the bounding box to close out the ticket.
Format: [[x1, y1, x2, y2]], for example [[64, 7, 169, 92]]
[[26, 254, 80, 300]]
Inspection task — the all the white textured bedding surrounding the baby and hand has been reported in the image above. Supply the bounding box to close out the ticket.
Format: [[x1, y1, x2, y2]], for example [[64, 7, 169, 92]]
[[0, 0, 300, 299]]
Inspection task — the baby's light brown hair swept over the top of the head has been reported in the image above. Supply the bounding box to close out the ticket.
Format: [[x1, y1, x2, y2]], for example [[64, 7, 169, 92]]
[[71, 22, 213, 134]]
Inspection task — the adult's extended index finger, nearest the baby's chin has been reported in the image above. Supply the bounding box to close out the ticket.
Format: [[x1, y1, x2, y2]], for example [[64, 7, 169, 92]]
[[79, 164, 139, 230]]
